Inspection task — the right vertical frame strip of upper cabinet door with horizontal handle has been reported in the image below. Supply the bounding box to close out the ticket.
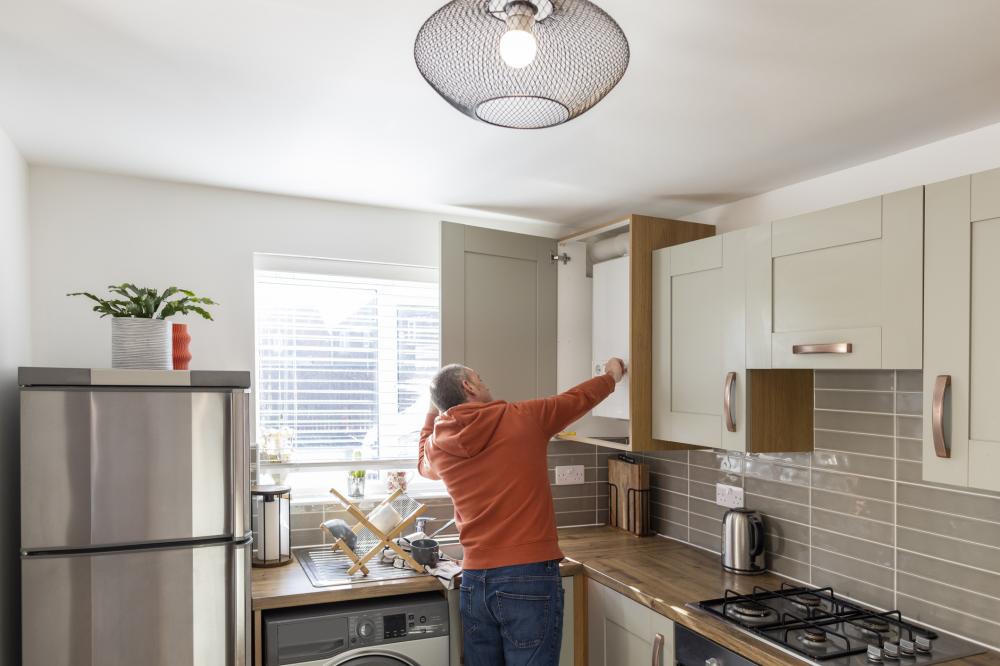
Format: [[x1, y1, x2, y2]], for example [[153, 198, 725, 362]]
[[882, 187, 924, 370]]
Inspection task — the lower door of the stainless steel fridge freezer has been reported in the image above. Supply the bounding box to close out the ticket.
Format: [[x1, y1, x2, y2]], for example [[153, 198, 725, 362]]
[[21, 543, 250, 666]]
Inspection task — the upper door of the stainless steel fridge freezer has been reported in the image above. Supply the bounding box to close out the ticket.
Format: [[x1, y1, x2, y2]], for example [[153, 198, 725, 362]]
[[21, 388, 249, 552]]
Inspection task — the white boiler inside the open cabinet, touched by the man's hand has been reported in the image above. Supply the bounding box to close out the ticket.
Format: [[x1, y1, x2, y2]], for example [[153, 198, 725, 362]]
[[591, 257, 631, 419]]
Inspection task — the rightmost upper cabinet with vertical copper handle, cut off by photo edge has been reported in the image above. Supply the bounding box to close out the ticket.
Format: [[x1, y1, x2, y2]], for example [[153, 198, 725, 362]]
[[923, 170, 1000, 491]]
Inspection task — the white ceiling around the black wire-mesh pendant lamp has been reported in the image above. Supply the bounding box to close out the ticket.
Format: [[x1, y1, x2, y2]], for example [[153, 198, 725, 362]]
[[0, 0, 1000, 231]]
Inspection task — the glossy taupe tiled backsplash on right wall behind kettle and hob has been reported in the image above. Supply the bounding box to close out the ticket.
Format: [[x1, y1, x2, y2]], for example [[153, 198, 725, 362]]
[[632, 371, 1000, 647]]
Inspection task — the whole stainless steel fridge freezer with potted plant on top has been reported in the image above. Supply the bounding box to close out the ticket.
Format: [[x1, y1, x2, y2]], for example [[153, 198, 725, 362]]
[[19, 368, 250, 666]]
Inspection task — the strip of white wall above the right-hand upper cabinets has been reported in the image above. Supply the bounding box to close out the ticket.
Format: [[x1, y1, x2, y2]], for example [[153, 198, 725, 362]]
[[686, 123, 1000, 233]]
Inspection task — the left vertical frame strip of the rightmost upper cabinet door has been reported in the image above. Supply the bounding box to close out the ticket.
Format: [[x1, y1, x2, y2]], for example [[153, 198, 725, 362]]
[[923, 176, 972, 486]]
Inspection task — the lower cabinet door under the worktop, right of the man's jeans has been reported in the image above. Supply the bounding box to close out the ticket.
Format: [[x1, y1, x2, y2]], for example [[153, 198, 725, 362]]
[[587, 579, 674, 666]]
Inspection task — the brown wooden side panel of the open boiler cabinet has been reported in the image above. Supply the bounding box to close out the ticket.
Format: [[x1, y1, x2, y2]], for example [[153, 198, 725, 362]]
[[627, 215, 715, 451]]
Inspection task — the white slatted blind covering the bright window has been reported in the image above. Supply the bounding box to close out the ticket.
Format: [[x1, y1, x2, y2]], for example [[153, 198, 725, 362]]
[[254, 270, 440, 461]]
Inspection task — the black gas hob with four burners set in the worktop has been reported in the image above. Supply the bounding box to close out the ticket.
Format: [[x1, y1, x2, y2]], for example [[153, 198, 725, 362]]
[[694, 583, 986, 666]]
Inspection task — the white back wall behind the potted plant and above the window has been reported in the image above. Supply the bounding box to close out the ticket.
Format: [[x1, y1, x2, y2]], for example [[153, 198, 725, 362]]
[[30, 166, 556, 370]]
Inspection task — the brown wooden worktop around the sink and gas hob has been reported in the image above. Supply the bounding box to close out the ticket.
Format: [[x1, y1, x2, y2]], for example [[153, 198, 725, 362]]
[[252, 527, 1000, 666]]
